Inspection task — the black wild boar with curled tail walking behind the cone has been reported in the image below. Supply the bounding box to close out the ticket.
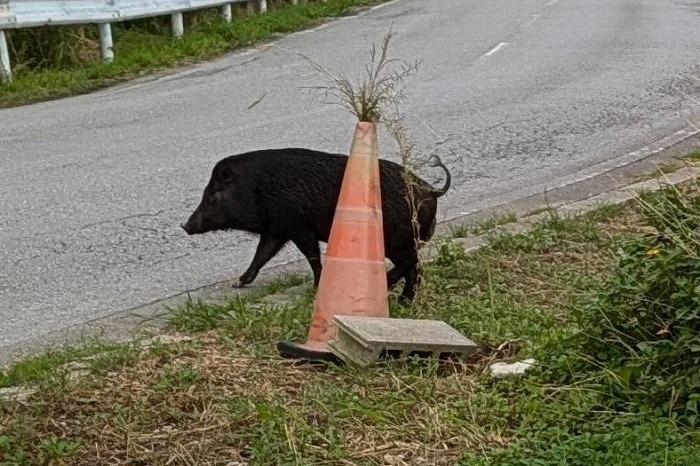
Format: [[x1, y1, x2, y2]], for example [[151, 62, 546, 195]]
[[182, 148, 451, 301]]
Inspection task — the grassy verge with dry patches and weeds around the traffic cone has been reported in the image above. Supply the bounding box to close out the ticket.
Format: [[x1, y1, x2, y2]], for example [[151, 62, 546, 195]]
[[0, 159, 700, 465]]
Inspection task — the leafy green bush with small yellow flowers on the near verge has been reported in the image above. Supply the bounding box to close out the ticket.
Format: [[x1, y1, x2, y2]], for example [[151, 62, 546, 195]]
[[555, 180, 700, 427]]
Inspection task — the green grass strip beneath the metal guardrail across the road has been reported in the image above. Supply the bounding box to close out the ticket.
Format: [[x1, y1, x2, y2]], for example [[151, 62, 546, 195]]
[[0, 0, 394, 108]]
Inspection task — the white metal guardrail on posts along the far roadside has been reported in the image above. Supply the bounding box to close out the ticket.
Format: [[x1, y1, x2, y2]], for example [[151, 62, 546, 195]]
[[0, 0, 298, 81]]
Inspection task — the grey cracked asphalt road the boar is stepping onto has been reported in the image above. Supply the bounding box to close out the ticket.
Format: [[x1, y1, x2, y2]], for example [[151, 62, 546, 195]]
[[0, 0, 700, 360]]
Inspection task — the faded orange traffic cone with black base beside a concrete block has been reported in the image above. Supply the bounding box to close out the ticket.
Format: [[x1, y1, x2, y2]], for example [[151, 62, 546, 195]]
[[277, 122, 389, 362]]
